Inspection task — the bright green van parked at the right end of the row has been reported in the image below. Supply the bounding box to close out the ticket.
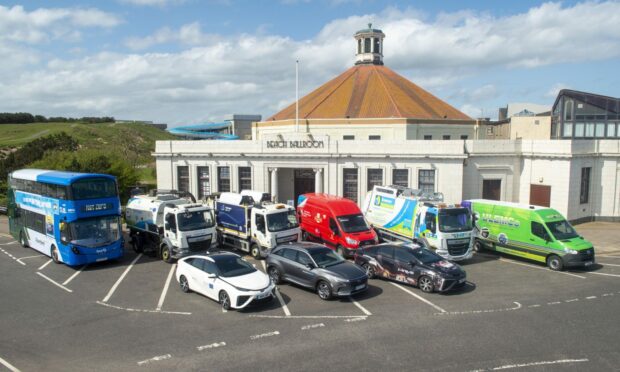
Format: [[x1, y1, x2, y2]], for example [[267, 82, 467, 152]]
[[462, 199, 594, 270]]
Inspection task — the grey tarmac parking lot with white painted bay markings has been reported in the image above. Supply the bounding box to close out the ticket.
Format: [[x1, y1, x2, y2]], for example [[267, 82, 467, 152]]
[[0, 219, 620, 371]]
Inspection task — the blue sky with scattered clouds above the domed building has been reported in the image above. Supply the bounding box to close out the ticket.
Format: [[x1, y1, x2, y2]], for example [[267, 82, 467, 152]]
[[0, 0, 620, 126]]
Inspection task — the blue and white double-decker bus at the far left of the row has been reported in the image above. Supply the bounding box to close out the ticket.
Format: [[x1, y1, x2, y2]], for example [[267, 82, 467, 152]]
[[7, 169, 123, 266]]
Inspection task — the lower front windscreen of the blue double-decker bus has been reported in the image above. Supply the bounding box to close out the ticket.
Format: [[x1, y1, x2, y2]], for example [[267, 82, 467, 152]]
[[67, 216, 121, 248]]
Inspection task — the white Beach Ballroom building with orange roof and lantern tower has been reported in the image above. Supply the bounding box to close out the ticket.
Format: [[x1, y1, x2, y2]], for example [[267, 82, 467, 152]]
[[153, 27, 620, 224]]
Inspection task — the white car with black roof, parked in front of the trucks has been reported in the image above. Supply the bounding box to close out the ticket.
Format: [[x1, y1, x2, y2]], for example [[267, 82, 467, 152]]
[[176, 252, 275, 310]]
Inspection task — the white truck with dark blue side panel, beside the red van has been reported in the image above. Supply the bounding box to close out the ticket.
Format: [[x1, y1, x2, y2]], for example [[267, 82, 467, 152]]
[[214, 190, 301, 259]]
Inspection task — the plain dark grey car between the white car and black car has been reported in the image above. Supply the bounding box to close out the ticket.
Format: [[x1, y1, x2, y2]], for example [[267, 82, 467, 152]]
[[267, 242, 368, 300]]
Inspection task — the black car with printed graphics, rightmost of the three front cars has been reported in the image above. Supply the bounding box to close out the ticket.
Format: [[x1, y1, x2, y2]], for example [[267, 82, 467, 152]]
[[355, 243, 467, 293]]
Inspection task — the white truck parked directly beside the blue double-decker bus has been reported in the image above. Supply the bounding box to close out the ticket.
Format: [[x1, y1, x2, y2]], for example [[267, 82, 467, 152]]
[[125, 190, 216, 263]]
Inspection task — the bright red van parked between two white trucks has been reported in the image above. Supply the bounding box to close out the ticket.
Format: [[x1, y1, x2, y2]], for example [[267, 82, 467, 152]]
[[297, 194, 379, 257]]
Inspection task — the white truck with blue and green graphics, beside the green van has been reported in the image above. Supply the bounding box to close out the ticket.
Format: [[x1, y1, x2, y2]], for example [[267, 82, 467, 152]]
[[362, 186, 473, 261]]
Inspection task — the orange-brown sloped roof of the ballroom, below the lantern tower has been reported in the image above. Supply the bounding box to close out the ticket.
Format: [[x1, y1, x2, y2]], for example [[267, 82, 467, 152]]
[[266, 64, 472, 121]]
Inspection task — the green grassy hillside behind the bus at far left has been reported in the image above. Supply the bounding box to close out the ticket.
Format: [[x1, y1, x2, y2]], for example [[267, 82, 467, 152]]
[[0, 123, 178, 164]]
